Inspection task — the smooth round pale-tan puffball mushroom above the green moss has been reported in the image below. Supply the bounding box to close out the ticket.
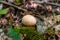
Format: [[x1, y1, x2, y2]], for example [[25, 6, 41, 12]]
[[22, 15, 37, 26]]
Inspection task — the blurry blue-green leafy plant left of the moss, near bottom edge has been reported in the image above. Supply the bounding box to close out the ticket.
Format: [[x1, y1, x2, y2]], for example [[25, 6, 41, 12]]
[[8, 27, 21, 40]]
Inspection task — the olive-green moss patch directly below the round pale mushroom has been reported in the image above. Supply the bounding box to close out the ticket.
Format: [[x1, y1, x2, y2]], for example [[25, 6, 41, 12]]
[[20, 27, 43, 40]]
